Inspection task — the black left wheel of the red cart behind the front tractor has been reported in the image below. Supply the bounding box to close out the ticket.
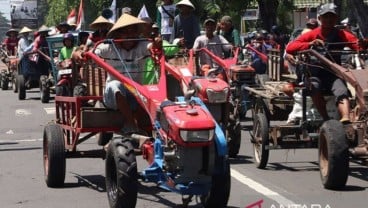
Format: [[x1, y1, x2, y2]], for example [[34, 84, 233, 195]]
[[43, 124, 66, 188]]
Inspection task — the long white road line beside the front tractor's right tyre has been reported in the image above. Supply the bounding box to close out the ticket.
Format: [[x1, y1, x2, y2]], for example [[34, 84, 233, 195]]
[[231, 168, 296, 207]]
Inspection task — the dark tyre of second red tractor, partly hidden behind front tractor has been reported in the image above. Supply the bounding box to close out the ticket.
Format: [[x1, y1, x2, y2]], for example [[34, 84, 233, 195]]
[[227, 122, 241, 158]]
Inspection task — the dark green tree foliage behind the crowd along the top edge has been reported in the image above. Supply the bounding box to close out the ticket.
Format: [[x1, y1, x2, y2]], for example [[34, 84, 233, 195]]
[[38, 0, 368, 34]]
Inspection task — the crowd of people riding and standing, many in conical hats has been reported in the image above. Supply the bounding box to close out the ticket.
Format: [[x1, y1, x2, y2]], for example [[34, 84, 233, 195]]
[[3, 0, 363, 129]]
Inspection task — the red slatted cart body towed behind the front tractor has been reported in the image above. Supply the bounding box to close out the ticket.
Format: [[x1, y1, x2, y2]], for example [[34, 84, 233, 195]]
[[55, 63, 123, 151]]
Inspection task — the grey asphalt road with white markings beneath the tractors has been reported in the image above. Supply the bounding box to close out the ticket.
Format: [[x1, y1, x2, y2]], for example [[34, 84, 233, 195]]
[[0, 85, 368, 208]]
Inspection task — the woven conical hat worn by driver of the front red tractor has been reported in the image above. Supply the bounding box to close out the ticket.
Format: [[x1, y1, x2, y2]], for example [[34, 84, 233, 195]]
[[107, 14, 147, 38]]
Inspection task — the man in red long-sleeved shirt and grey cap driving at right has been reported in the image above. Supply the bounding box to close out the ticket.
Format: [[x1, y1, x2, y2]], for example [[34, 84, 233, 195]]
[[286, 3, 366, 123]]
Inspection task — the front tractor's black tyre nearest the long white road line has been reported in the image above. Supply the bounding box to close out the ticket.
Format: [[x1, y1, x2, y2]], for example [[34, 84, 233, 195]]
[[200, 157, 231, 208]]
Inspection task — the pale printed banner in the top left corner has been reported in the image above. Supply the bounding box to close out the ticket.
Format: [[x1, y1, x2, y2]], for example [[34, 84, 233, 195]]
[[10, 0, 38, 29]]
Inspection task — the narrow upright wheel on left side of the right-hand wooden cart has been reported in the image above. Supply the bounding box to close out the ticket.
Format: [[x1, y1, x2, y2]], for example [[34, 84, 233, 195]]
[[253, 113, 270, 169]]
